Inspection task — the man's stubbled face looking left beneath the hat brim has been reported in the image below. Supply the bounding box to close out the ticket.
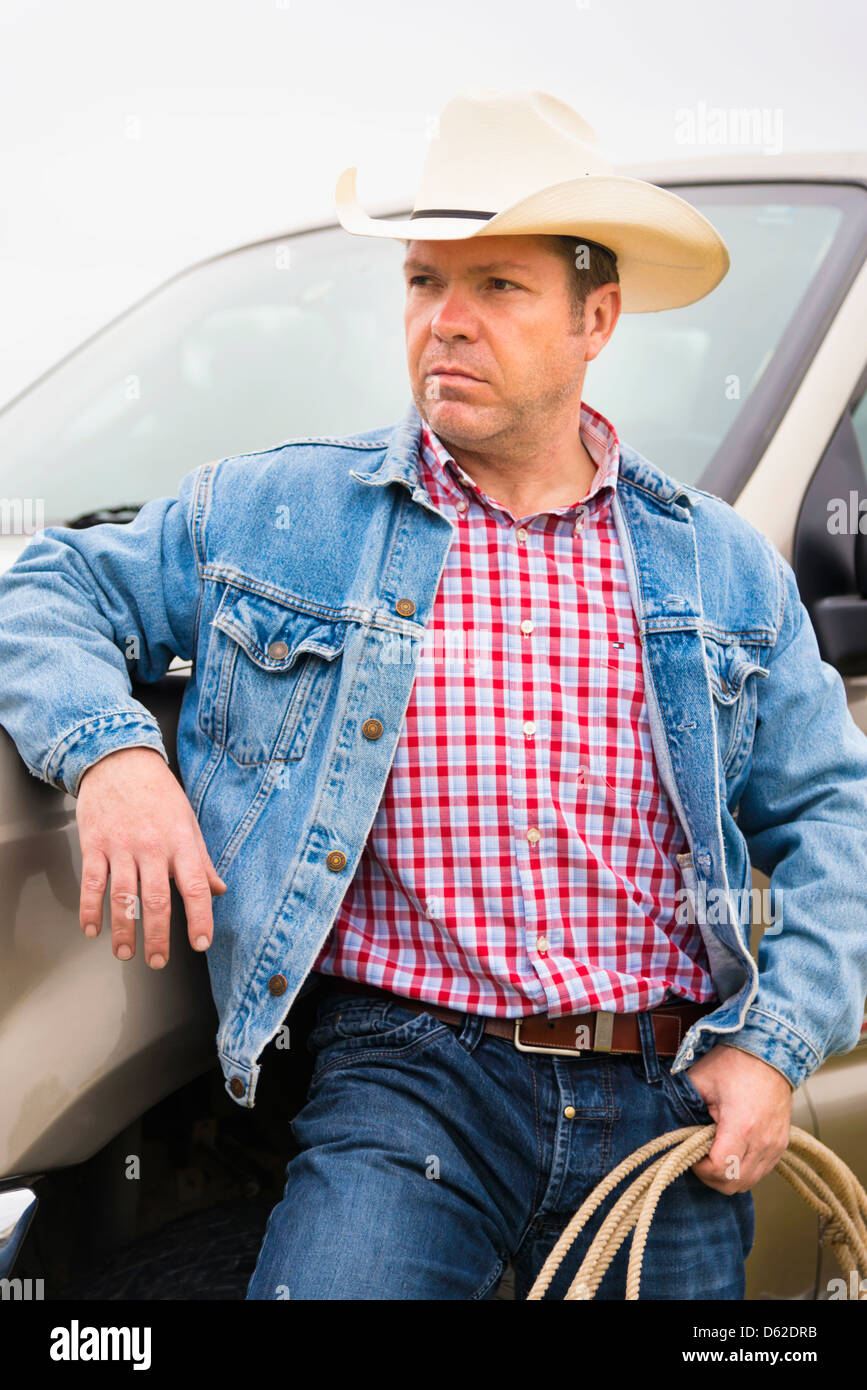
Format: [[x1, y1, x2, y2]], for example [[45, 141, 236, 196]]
[[404, 236, 620, 449]]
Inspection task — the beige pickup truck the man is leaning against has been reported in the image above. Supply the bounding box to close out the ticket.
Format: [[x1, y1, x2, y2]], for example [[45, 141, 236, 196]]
[[0, 154, 867, 1300]]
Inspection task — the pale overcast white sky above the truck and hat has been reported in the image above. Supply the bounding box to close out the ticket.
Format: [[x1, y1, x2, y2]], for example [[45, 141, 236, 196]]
[[0, 0, 867, 404]]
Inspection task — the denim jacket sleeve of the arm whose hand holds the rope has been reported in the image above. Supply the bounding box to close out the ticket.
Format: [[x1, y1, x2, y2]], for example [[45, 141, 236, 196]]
[[725, 541, 867, 1087]]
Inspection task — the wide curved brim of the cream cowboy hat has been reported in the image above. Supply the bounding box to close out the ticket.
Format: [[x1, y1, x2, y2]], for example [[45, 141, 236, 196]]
[[335, 168, 731, 314]]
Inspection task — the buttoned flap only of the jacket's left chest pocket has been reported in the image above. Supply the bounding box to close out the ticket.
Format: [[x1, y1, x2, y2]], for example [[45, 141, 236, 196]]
[[214, 589, 347, 671]]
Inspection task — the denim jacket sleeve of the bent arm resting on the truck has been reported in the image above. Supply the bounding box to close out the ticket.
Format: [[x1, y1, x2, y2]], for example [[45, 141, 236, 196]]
[[0, 463, 214, 796]]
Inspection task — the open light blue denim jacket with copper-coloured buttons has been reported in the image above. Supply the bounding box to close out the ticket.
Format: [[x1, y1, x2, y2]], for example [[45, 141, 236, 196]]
[[0, 403, 867, 1106]]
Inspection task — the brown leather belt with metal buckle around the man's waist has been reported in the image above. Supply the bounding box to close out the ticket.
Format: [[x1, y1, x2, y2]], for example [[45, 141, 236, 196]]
[[324, 976, 720, 1056]]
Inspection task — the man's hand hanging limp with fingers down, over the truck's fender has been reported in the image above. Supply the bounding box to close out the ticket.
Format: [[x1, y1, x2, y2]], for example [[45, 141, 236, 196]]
[[75, 748, 226, 970]]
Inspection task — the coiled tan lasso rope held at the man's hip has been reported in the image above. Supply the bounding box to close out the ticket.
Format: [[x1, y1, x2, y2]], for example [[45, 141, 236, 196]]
[[527, 1125, 867, 1300]]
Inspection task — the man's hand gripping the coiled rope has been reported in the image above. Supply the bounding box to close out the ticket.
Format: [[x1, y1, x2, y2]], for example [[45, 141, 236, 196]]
[[688, 1043, 793, 1195]]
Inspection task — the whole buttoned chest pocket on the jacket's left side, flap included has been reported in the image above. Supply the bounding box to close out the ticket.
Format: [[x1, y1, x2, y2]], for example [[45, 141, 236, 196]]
[[197, 587, 347, 766]]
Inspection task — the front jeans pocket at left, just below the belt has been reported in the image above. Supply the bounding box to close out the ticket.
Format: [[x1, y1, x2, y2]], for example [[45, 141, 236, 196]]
[[307, 994, 449, 1081]]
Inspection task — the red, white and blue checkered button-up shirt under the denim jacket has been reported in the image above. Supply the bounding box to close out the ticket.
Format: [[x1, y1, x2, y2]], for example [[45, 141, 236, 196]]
[[314, 404, 716, 1017]]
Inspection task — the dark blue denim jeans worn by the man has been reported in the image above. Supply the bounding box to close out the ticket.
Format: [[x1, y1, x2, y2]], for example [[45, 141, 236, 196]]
[[247, 994, 754, 1300]]
